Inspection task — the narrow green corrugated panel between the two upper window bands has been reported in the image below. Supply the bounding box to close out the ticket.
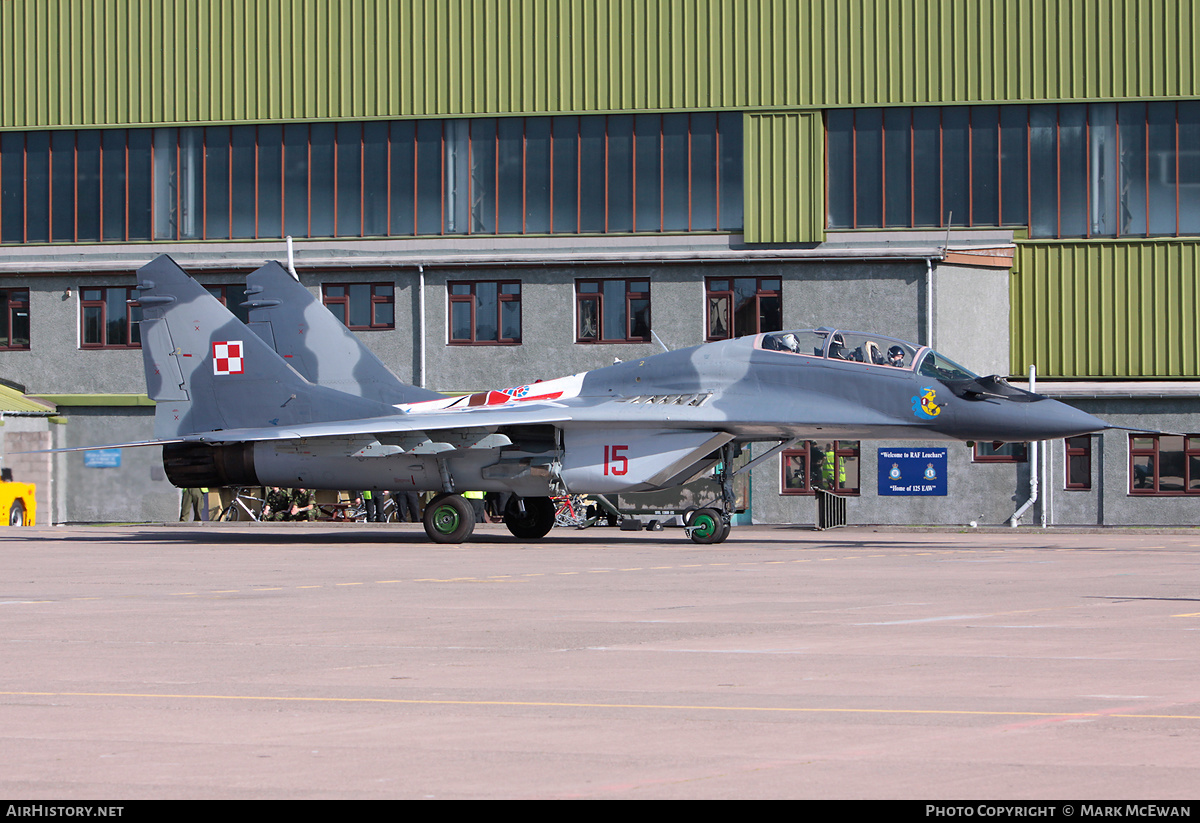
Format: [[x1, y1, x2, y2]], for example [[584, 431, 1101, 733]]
[[743, 112, 824, 242]]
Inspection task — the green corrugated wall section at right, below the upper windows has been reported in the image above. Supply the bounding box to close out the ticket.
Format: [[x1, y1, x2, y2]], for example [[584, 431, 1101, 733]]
[[1009, 240, 1200, 378]]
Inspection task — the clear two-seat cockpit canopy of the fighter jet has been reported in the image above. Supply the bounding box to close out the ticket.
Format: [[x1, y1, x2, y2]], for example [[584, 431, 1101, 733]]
[[758, 328, 978, 380]]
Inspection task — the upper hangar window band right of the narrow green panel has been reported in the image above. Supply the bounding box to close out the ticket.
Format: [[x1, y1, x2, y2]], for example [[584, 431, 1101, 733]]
[[826, 101, 1200, 238]]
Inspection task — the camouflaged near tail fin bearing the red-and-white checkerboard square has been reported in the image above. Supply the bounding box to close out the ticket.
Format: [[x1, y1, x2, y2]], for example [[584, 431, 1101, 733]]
[[138, 254, 395, 439]]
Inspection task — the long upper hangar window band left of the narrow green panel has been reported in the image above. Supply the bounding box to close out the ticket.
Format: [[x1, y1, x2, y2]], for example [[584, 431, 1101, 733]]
[[0, 112, 743, 244]]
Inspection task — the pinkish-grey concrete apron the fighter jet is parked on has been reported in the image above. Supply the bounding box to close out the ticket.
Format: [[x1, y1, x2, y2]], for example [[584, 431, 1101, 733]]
[[0, 524, 1200, 800]]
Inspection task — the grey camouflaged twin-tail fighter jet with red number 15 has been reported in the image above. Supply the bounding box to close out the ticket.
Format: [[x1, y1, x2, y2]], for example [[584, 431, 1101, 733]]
[[138, 256, 1106, 543]]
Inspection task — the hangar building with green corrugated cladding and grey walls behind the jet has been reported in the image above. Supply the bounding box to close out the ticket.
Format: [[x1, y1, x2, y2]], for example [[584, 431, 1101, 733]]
[[0, 0, 1200, 524]]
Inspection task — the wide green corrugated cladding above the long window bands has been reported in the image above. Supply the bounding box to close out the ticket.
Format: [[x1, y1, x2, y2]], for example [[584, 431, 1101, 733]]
[[0, 0, 1200, 128]]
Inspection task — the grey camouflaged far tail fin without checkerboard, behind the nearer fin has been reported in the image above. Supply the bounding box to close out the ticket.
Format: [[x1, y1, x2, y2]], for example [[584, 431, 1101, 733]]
[[246, 262, 444, 404]]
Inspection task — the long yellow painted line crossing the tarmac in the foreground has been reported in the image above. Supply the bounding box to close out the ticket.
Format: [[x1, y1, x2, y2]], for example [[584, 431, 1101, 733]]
[[0, 691, 1200, 720]]
